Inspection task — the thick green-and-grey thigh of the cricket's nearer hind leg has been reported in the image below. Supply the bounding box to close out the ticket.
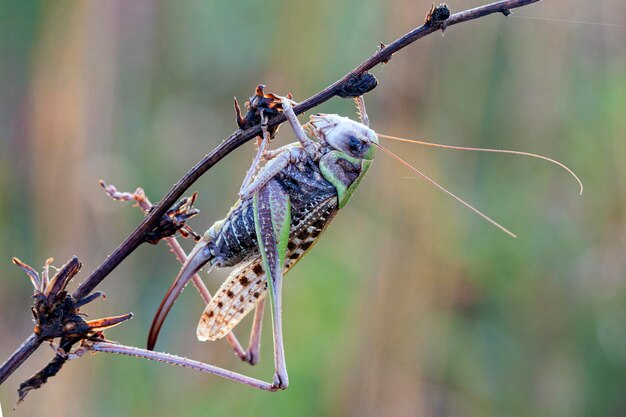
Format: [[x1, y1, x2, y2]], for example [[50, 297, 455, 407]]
[[254, 180, 291, 389]]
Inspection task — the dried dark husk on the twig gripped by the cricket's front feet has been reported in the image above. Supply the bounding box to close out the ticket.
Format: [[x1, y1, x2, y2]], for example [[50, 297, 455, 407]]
[[234, 84, 292, 139]]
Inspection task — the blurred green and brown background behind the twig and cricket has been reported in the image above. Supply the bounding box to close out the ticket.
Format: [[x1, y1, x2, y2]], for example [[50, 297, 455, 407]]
[[0, 0, 626, 417]]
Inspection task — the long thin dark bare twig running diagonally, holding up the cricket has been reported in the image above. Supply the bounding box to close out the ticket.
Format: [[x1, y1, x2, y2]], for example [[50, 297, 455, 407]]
[[0, 0, 540, 384]]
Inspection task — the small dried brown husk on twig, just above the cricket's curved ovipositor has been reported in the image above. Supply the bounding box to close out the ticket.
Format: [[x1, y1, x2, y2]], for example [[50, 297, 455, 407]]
[[144, 193, 200, 245]]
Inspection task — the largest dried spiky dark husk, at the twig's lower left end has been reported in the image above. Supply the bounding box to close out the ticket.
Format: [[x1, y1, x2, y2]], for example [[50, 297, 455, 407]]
[[13, 256, 132, 404]]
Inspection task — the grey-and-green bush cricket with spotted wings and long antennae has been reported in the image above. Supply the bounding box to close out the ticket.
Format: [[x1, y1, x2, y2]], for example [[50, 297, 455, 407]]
[[143, 91, 582, 391]]
